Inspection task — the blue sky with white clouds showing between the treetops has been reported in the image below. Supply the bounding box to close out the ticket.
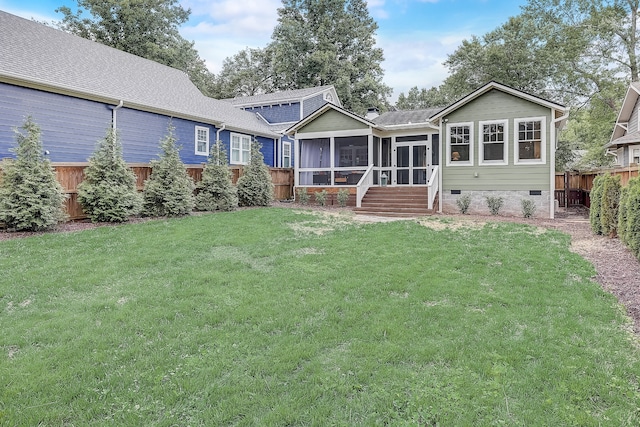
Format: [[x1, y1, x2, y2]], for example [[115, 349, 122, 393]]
[[0, 0, 526, 103]]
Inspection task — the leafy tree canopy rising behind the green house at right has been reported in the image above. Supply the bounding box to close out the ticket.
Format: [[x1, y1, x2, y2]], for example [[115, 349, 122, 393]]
[[397, 0, 640, 168]]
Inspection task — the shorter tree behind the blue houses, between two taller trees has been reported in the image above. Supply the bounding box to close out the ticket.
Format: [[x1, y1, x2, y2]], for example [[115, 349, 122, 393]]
[[214, 46, 275, 99]]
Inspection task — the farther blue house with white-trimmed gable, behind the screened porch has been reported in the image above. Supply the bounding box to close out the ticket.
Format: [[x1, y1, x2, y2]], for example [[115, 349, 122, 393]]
[[225, 85, 342, 168]]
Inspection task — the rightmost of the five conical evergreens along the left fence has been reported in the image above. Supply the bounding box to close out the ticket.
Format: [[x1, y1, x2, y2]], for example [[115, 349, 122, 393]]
[[238, 139, 273, 206]]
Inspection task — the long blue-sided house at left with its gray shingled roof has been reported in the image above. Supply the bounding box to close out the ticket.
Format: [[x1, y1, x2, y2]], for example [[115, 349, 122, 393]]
[[0, 11, 282, 167]]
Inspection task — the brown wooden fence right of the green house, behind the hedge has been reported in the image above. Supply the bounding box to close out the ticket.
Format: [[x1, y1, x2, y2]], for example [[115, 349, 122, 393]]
[[555, 165, 640, 207]]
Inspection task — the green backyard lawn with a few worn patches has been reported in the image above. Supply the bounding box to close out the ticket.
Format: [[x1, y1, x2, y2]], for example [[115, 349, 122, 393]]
[[0, 208, 640, 426]]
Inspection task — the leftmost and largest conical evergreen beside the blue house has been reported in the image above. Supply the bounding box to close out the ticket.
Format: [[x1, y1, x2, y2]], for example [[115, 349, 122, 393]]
[[0, 116, 66, 231]]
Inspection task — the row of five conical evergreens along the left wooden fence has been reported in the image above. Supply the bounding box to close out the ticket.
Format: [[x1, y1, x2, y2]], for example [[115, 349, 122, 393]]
[[0, 117, 273, 231]]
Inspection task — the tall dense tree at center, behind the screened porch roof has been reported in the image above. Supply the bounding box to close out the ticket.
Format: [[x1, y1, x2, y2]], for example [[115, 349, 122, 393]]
[[270, 0, 391, 114]]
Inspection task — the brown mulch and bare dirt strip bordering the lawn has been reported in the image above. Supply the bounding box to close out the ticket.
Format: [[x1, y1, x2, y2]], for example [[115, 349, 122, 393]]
[[0, 203, 640, 335]]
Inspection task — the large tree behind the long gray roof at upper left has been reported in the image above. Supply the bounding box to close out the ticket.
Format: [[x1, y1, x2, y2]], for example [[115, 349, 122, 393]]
[[56, 0, 214, 95]]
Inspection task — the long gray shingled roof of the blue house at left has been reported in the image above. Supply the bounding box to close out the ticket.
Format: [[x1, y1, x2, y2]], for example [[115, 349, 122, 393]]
[[0, 11, 277, 137]]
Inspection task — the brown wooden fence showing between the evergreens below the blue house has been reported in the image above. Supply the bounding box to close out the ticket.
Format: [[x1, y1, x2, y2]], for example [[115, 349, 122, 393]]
[[53, 163, 293, 219]]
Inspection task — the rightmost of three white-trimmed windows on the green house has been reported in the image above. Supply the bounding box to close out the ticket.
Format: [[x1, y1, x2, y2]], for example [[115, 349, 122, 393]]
[[513, 117, 547, 165]]
